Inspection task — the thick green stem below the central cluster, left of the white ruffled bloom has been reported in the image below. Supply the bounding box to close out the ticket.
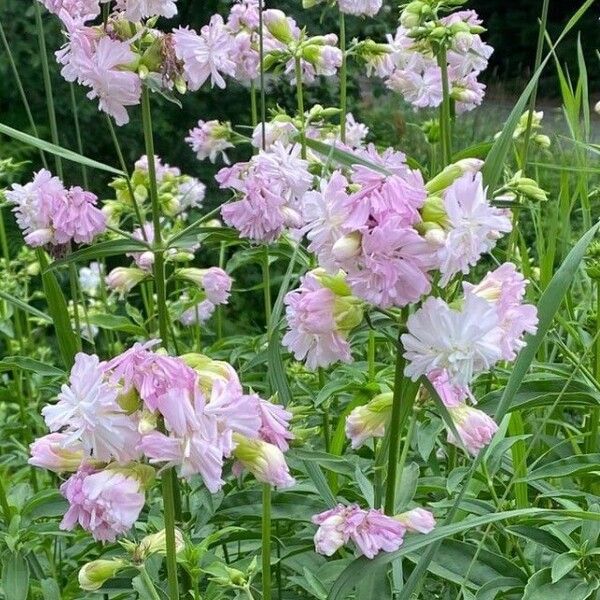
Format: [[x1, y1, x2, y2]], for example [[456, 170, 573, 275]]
[[384, 326, 419, 515]]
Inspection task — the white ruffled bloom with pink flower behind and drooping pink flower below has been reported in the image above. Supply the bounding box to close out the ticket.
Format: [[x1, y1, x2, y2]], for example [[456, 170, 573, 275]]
[[402, 263, 537, 454]]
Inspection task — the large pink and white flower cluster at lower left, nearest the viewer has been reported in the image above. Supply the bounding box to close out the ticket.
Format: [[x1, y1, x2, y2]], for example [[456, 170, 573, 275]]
[[30, 340, 294, 540]]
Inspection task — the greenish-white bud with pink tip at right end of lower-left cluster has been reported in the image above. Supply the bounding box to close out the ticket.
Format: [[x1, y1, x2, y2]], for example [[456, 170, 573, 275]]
[[233, 433, 295, 488]]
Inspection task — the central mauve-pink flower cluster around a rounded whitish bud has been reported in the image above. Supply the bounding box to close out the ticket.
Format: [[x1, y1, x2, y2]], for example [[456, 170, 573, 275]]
[[305, 146, 436, 307]]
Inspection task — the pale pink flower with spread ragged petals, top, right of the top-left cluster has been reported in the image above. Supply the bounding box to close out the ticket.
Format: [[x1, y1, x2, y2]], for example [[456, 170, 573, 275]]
[[172, 15, 236, 91]]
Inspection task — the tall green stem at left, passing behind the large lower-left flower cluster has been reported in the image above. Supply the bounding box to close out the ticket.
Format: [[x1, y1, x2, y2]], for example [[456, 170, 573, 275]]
[[142, 87, 179, 600]]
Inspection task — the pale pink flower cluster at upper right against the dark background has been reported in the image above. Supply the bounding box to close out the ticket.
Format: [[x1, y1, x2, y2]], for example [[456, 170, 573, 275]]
[[367, 11, 493, 113]]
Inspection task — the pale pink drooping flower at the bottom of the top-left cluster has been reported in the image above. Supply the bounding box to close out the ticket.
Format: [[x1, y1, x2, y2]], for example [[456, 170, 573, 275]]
[[78, 36, 142, 125]]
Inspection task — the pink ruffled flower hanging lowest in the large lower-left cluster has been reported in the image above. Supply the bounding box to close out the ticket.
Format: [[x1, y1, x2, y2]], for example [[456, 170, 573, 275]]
[[60, 467, 145, 542]]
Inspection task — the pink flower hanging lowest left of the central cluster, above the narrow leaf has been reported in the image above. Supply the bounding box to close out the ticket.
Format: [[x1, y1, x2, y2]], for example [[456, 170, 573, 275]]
[[282, 274, 352, 369]]
